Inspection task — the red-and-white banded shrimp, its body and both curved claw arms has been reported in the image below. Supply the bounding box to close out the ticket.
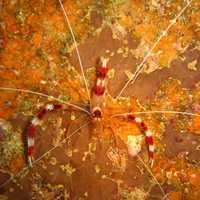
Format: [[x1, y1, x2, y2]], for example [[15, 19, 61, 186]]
[[27, 57, 154, 167]]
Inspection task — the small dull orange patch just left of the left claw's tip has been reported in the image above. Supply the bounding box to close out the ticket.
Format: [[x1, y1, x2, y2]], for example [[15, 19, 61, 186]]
[[9, 155, 25, 174]]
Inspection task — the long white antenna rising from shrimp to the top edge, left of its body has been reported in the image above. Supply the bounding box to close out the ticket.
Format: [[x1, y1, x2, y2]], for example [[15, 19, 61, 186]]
[[58, 0, 90, 101]]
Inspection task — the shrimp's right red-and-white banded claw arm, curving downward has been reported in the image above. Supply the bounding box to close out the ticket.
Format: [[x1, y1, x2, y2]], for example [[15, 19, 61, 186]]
[[127, 114, 154, 167]]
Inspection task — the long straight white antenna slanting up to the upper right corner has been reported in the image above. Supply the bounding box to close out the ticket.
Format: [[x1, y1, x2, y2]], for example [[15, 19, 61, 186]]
[[116, 0, 193, 99]]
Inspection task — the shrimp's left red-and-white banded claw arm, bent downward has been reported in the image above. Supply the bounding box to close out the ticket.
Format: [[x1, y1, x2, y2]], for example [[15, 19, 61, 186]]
[[27, 104, 64, 167]]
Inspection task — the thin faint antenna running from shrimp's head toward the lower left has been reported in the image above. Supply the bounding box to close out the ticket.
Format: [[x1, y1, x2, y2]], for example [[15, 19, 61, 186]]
[[0, 122, 89, 188]]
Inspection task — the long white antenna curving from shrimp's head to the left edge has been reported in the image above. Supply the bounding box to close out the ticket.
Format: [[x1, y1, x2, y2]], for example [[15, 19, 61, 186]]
[[0, 87, 90, 115]]
